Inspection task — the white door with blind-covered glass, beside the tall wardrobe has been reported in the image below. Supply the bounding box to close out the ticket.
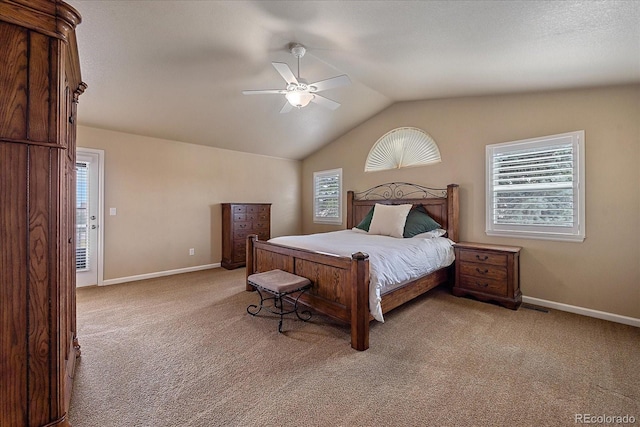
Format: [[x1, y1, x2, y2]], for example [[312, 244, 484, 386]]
[[76, 148, 104, 287]]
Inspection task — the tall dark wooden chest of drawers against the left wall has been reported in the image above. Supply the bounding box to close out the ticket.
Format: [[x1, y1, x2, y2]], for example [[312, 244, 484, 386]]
[[221, 203, 271, 269]]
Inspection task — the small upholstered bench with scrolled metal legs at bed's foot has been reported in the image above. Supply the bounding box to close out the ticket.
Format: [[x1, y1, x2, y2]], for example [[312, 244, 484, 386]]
[[247, 270, 312, 333]]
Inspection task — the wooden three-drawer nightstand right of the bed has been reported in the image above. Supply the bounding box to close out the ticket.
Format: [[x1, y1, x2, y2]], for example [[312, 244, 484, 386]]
[[452, 242, 522, 310]]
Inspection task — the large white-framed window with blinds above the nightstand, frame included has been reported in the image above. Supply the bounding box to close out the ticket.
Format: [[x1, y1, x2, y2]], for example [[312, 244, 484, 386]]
[[486, 131, 585, 242]]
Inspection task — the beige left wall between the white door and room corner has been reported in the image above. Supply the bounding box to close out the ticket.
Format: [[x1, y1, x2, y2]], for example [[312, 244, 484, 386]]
[[78, 126, 301, 280]]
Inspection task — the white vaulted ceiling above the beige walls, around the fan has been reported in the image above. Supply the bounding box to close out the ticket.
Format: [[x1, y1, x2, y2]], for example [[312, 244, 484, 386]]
[[67, 0, 640, 159]]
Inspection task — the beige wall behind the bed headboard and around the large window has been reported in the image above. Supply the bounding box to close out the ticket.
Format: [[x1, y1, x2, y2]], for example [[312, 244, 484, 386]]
[[302, 85, 640, 318]]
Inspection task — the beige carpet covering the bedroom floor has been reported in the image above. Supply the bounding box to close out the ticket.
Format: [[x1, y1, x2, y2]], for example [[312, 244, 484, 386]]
[[70, 269, 640, 427]]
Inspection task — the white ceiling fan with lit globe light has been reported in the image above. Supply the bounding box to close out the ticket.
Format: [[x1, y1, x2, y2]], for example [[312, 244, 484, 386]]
[[242, 43, 351, 113]]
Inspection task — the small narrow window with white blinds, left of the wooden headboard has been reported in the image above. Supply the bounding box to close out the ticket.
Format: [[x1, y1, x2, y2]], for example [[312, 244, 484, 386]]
[[313, 169, 342, 224]]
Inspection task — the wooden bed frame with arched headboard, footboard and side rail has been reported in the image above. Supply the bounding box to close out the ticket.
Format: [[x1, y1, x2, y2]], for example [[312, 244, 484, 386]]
[[246, 183, 459, 351]]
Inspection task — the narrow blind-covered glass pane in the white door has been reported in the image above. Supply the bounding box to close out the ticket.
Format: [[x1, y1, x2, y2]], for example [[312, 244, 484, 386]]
[[76, 162, 89, 270]]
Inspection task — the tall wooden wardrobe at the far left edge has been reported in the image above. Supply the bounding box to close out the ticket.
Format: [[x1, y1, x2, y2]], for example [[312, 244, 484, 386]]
[[0, 0, 86, 427]]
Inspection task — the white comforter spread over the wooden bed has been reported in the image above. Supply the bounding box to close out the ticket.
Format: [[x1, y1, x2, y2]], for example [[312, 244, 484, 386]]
[[269, 230, 454, 322]]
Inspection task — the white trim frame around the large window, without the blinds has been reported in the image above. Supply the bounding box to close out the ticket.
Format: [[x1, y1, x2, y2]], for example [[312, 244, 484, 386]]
[[485, 130, 585, 242]]
